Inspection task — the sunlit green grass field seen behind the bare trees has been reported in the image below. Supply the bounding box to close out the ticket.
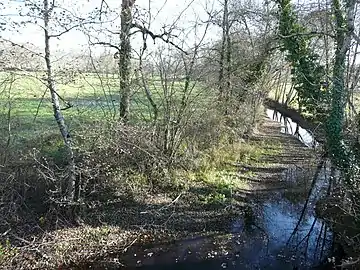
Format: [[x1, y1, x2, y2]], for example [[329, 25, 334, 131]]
[[0, 72, 210, 144]]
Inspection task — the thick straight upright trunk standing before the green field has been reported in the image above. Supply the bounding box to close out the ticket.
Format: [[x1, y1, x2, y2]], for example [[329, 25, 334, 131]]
[[119, 0, 135, 122]]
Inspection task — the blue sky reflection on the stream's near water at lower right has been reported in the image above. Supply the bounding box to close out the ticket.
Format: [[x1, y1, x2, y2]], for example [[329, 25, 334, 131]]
[[225, 166, 332, 269]]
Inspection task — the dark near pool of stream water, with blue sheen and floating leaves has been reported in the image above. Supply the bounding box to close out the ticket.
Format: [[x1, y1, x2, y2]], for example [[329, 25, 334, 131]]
[[129, 174, 332, 270]]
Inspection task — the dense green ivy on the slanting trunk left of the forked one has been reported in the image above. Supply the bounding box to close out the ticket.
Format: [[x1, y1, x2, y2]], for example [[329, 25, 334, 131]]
[[277, 0, 328, 119]]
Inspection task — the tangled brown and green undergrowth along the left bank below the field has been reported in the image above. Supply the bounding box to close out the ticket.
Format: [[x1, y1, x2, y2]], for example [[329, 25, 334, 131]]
[[0, 100, 268, 268]]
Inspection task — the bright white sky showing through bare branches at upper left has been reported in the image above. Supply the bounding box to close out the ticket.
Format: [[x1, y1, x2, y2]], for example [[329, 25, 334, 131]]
[[0, 0, 219, 52]]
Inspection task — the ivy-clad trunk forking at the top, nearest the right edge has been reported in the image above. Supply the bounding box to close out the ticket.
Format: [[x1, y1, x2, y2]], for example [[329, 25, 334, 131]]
[[326, 0, 356, 178]]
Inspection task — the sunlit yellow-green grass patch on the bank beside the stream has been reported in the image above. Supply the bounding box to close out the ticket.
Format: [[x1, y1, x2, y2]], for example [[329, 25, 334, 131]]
[[169, 140, 282, 205]]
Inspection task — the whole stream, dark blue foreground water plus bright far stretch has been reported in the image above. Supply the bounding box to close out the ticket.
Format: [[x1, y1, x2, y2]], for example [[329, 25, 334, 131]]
[[88, 109, 332, 270]]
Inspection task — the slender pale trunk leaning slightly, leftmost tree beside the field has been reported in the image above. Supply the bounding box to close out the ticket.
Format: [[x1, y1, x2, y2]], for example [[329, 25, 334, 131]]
[[44, 0, 80, 202]]
